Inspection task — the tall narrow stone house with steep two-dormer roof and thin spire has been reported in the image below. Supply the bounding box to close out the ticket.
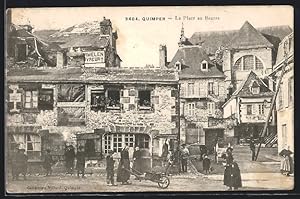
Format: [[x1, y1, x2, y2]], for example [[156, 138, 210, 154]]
[[168, 24, 226, 151]]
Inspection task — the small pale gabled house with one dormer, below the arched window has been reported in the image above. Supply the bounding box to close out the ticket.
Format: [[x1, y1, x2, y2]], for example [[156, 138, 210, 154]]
[[223, 71, 274, 141]]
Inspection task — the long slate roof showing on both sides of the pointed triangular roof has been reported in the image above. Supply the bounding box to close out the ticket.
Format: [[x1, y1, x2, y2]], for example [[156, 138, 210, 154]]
[[189, 22, 292, 55]]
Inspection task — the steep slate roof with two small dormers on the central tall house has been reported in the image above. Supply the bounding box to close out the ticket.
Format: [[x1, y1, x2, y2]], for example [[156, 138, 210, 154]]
[[168, 45, 224, 79]]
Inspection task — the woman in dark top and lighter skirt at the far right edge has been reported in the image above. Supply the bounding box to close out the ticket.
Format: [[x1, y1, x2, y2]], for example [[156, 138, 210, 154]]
[[279, 146, 293, 176]]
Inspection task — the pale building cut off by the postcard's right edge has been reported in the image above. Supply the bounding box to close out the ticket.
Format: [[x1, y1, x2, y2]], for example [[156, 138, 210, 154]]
[[270, 33, 295, 152]]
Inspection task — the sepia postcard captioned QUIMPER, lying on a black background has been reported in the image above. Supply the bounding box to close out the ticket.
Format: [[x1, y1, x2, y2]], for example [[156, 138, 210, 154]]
[[5, 5, 294, 194]]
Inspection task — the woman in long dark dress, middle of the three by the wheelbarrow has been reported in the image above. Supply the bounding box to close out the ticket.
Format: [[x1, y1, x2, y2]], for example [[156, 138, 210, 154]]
[[117, 145, 131, 185]]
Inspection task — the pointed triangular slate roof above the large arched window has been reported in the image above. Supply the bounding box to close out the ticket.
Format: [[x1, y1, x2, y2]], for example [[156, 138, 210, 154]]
[[229, 21, 273, 49]]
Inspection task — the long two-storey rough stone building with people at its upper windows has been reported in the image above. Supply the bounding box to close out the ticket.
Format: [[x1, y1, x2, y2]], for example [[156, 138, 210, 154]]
[[6, 15, 178, 169]]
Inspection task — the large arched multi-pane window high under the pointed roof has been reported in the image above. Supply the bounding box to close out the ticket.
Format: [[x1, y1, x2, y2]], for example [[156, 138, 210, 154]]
[[234, 55, 264, 71]]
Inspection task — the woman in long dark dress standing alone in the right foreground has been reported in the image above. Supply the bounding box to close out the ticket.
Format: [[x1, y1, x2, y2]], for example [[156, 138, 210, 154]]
[[223, 148, 242, 190]]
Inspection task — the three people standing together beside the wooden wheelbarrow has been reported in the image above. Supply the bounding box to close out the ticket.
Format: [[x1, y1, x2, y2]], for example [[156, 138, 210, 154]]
[[106, 145, 142, 186]]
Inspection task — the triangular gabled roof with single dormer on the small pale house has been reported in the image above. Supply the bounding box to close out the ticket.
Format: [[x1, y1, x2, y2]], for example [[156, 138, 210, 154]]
[[232, 71, 274, 97]]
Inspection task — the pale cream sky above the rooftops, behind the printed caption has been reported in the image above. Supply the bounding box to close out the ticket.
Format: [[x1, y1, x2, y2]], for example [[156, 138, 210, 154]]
[[12, 6, 294, 67]]
